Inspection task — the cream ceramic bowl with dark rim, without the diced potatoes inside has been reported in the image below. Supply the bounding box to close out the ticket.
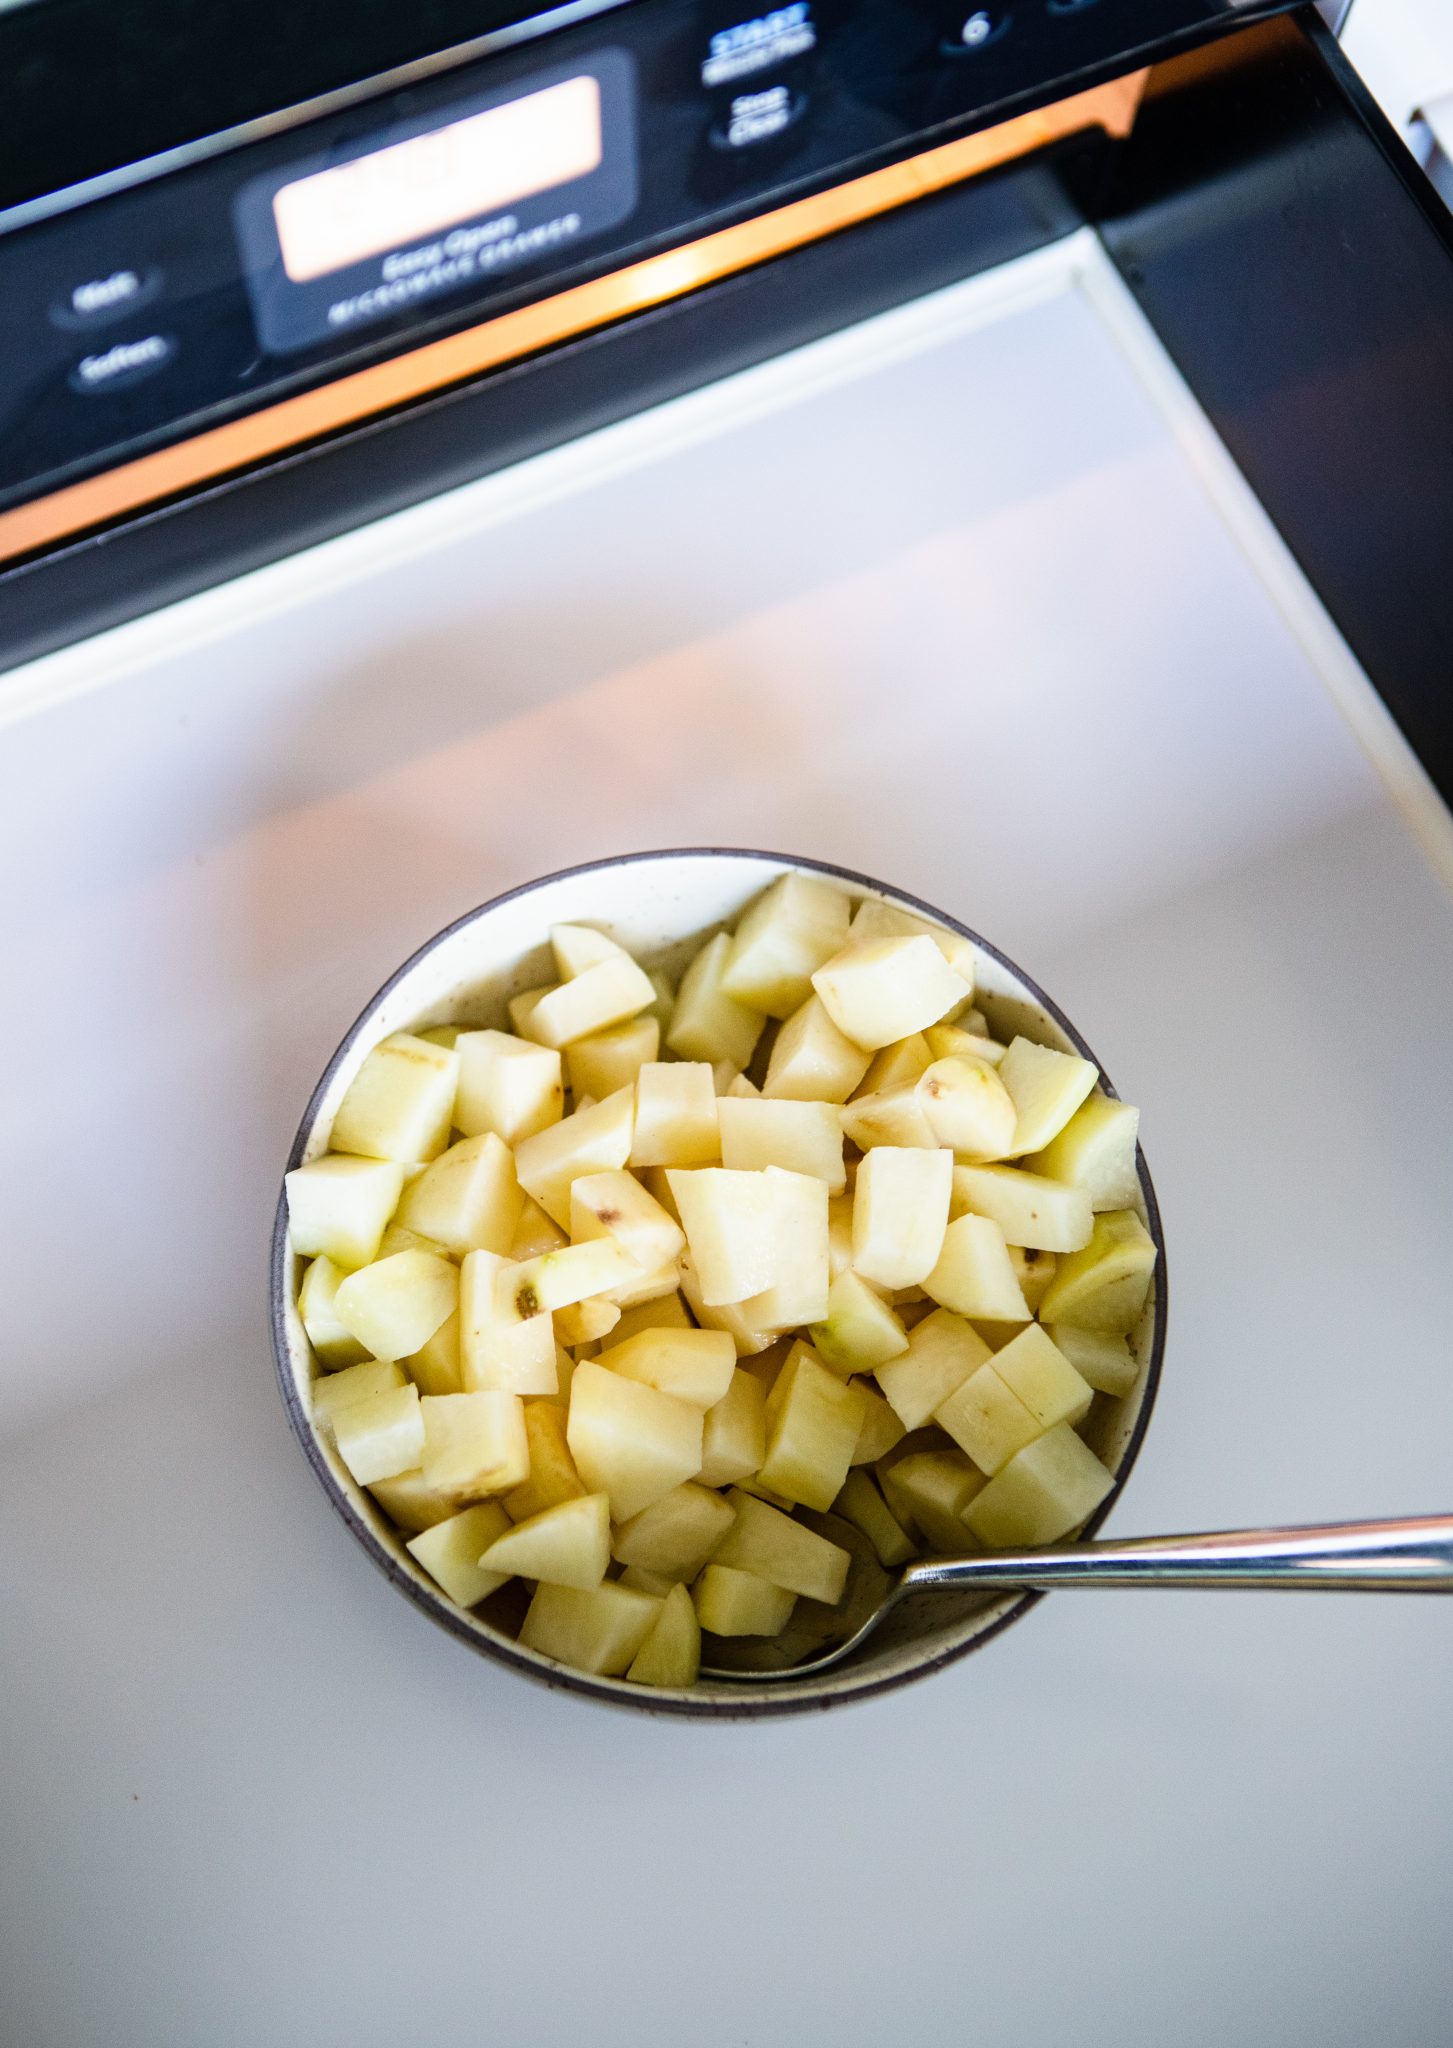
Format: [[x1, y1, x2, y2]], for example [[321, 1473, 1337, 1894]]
[[271, 848, 1166, 1718]]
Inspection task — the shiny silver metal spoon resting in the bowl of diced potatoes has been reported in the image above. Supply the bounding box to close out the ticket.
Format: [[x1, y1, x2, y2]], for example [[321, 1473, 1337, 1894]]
[[701, 1516, 1453, 1686]]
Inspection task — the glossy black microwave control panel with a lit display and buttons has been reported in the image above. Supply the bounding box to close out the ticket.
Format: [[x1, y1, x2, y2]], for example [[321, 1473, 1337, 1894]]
[[0, 0, 1285, 506]]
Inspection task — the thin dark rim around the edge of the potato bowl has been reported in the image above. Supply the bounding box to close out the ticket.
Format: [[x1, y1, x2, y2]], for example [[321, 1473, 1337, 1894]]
[[268, 846, 1168, 1720]]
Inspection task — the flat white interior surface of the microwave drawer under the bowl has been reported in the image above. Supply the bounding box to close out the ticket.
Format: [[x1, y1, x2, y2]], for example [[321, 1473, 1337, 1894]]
[[0, 238, 1453, 2048]]
